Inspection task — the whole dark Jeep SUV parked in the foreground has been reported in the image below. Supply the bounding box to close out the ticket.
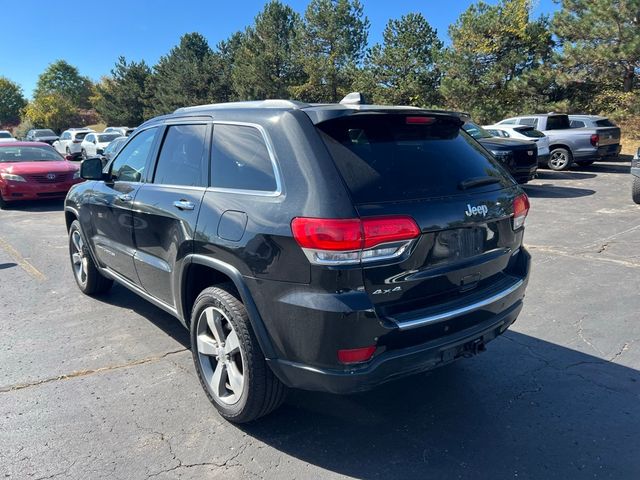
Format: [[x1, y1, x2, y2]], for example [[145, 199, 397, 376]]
[[65, 95, 530, 422]]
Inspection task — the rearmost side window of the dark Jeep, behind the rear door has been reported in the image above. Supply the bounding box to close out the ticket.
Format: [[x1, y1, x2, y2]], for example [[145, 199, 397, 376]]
[[211, 125, 277, 192]]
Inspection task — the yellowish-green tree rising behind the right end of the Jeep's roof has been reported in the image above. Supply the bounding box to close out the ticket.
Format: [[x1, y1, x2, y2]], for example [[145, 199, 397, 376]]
[[442, 0, 553, 122]]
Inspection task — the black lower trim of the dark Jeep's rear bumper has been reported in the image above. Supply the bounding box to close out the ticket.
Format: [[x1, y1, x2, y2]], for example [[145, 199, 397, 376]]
[[268, 300, 522, 394]]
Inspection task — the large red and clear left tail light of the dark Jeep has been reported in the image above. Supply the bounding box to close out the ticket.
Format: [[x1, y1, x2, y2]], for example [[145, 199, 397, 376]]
[[291, 216, 420, 265]]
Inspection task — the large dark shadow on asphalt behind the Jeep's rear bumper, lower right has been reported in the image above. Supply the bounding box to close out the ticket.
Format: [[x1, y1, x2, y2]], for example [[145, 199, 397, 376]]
[[242, 332, 640, 479]]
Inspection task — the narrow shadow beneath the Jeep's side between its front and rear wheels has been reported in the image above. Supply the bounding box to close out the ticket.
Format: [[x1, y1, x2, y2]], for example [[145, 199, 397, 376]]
[[94, 283, 191, 348]]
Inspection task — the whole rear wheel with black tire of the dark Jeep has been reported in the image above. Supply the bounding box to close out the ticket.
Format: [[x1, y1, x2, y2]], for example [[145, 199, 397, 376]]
[[191, 285, 286, 423]]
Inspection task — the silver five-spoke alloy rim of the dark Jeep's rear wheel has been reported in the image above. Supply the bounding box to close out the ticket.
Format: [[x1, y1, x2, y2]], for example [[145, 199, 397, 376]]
[[196, 307, 245, 405]]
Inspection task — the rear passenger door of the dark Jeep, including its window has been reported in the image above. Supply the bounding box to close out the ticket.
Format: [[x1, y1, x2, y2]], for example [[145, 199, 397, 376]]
[[134, 122, 211, 306]]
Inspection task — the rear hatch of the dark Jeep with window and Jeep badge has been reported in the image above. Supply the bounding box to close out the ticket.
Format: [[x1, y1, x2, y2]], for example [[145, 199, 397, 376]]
[[316, 111, 526, 322]]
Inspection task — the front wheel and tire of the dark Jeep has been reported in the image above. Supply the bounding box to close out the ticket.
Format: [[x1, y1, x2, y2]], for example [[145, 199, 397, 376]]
[[69, 220, 113, 295]]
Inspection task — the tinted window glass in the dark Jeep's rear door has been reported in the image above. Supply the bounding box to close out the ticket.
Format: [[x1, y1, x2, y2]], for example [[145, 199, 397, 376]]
[[153, 125, 207, 187]]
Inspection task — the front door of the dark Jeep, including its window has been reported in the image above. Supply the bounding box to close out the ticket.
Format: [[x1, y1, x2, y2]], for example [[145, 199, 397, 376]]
[[90, 127, 159, 284]]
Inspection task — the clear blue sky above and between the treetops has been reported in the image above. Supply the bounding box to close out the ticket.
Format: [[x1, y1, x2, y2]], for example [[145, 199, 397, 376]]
[[0, 0, 558, 96]]
